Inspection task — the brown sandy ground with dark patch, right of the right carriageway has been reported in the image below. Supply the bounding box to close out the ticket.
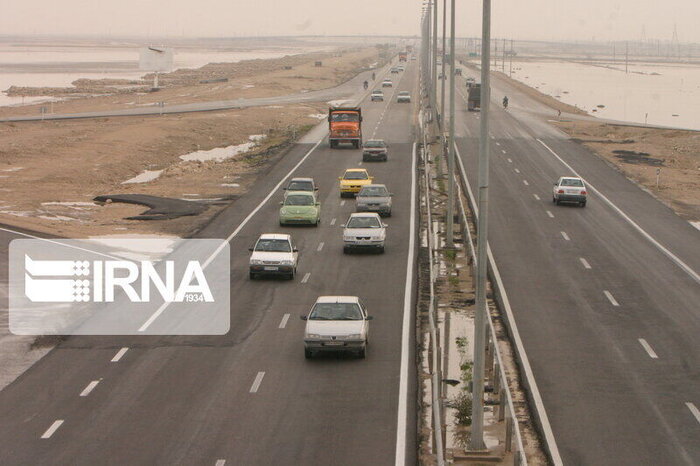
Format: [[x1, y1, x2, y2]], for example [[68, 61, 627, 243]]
[[556, 121, 700, 222]]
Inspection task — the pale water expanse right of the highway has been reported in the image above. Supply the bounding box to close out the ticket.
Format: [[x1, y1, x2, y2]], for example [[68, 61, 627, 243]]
[[506, 61, 700, 130]]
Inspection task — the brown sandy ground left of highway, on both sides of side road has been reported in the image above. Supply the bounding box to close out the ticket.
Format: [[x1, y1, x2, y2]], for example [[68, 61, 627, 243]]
[[0, 48, 388, 237]]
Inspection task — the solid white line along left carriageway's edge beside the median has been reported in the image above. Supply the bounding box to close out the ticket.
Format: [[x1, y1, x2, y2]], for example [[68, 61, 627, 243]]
[[395, 142, 416, 466]]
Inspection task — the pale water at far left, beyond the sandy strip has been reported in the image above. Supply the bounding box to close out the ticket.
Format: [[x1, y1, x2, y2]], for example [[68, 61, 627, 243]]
[[0, 43, 328, 106]]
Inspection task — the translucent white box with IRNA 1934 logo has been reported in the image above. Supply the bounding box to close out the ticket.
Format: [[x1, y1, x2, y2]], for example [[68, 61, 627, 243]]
[[9, 238, 230, 335]]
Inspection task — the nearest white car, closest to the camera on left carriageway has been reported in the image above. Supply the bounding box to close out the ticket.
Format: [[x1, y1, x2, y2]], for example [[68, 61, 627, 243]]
[[301, 296, 372, 359]]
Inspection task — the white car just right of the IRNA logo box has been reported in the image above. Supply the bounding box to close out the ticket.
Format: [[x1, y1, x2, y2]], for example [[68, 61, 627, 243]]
[[249, 233, 299, 280]]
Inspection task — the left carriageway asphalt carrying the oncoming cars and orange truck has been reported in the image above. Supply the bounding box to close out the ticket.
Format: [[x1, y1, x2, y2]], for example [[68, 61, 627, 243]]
[[0, 62, 417, 466]]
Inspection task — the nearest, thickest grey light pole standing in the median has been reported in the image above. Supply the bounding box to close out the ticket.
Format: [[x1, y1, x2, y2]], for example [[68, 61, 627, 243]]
[[469, 0, 491, 450]]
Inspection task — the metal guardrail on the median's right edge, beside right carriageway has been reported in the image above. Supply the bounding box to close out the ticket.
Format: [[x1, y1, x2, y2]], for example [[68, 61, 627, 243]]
[[455, 150, 527, 466]]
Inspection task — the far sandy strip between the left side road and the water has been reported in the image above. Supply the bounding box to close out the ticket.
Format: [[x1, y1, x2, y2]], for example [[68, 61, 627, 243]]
[[0, 47, 382, 118]]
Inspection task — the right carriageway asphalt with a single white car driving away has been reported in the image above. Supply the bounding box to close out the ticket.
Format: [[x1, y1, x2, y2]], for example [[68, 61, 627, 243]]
[[456, 66, 700, 466]]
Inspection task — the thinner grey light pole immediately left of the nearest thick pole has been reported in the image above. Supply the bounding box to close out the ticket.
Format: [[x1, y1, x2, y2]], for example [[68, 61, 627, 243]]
[[442, 0, 455, 248]]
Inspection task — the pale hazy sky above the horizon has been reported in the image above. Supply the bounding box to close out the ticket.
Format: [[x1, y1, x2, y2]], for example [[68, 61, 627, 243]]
[[0, 0, 700, 42]]
